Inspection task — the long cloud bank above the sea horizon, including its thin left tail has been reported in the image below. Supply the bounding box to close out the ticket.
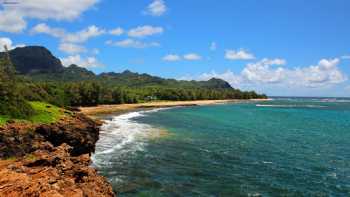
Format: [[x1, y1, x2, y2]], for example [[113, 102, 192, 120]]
[[187, 58, 348, 88]]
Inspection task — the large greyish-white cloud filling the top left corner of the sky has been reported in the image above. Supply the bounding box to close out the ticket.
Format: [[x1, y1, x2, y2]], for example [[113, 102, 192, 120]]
[[0, 0, 99, 33]]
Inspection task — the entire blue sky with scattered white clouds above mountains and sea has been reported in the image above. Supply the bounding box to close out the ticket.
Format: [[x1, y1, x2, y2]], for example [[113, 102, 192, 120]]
[[0, 0, 350, 97]]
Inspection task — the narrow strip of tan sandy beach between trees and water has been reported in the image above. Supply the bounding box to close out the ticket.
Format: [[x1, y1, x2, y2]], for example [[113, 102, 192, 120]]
[[79, 99, 271, 117]]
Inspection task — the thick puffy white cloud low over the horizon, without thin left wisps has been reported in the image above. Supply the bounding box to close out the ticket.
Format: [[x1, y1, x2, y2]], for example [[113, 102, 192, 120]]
[[241, 58, 347, 87]]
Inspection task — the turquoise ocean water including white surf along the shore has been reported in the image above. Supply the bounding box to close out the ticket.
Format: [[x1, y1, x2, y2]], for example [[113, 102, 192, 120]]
[[93, 98, 350, 196]]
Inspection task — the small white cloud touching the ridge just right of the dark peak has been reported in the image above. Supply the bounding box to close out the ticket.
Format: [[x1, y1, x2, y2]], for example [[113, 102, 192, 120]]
[[61, 55, 104, 68]]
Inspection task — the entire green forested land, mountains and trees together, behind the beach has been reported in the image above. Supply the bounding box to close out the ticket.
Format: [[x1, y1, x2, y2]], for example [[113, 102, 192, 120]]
[[0, 46, 266, 117]]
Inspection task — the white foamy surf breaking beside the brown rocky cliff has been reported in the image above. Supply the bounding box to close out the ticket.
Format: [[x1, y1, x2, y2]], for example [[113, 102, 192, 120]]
[[92, 109, 163, 166]]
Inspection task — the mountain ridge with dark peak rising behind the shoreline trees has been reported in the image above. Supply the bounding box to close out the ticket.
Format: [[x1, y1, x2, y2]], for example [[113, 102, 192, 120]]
[[0, 46, 232, 89]]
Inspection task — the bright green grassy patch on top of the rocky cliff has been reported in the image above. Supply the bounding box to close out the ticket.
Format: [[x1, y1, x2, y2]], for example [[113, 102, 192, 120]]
[[0, 102, 71, 125]]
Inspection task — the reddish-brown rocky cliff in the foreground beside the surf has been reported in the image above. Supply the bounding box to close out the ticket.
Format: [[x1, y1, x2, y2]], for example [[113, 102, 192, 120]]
[[0, 114, 114, 197]]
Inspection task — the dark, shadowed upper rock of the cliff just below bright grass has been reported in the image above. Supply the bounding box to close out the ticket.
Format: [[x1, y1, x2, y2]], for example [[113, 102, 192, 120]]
[[0, 114, 99, 158]]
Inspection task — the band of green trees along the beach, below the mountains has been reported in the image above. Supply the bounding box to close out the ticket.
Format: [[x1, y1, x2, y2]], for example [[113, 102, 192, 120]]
[[21, 81, 265, 106]]
